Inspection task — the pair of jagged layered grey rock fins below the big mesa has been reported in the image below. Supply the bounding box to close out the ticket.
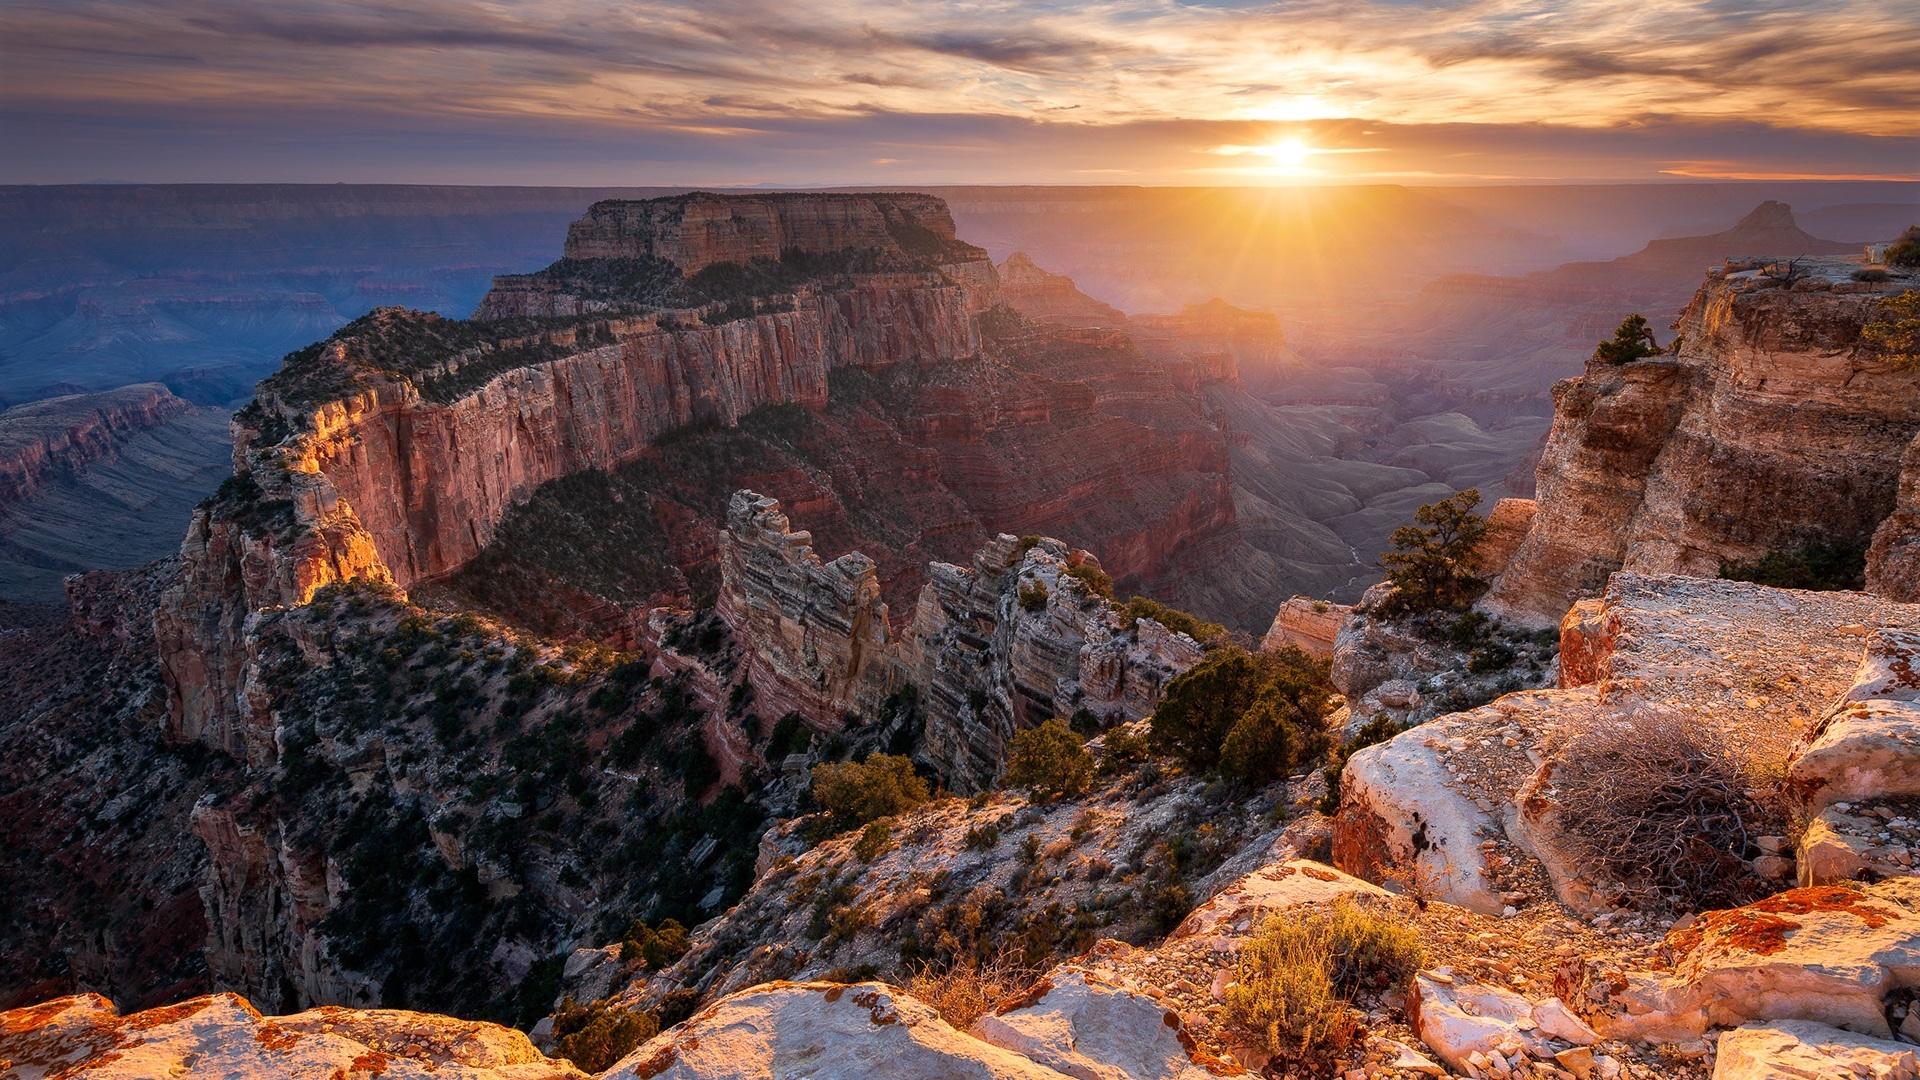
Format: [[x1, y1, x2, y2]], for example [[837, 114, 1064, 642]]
[[720, 492, 1202, 786]]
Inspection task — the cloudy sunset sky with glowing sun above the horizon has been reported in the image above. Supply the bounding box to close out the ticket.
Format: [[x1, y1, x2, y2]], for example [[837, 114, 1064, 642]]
[[0, 0, 1920, 186]]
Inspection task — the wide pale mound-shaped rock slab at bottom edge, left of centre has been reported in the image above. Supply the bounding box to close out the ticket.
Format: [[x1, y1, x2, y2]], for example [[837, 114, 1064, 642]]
[[601, 982, 1075, 1080]]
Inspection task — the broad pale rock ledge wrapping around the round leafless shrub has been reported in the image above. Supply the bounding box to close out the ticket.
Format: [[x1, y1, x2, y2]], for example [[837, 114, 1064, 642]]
[[1334, 573, 1920, 913]]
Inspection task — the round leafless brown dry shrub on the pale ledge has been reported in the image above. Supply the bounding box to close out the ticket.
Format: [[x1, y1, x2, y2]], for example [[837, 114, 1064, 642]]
[[1553, 713, 1784, 911]]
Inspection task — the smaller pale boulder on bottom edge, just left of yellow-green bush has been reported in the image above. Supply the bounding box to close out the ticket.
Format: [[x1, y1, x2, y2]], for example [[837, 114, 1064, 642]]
[[972, 965, 1240, 1080]]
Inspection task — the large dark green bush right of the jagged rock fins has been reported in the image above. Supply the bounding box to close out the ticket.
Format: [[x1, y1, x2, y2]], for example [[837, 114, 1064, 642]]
[[1152, 648, 1332, 768]]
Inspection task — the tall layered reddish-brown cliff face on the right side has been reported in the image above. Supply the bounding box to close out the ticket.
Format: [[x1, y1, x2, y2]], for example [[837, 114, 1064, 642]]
[[1484, 259, 1920, 626]]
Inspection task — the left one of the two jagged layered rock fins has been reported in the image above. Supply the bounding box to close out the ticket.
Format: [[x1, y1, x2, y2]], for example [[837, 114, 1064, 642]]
[[720, 492, 897, 730]]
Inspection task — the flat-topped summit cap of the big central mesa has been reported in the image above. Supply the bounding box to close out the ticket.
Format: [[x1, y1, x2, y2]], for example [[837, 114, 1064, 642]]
[[552, 192, 987, 275]]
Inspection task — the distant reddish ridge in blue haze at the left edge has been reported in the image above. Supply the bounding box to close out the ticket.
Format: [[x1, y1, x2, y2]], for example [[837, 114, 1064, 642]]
[[0, 382, 194, 507]]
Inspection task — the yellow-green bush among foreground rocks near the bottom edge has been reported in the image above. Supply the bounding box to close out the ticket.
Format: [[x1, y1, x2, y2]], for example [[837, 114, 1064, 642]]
[[1227, 899, 1423, 1070]]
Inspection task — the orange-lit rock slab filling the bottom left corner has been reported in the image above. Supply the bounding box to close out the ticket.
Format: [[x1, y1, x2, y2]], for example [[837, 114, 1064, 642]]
[[0, 994, 586, 1080]]
